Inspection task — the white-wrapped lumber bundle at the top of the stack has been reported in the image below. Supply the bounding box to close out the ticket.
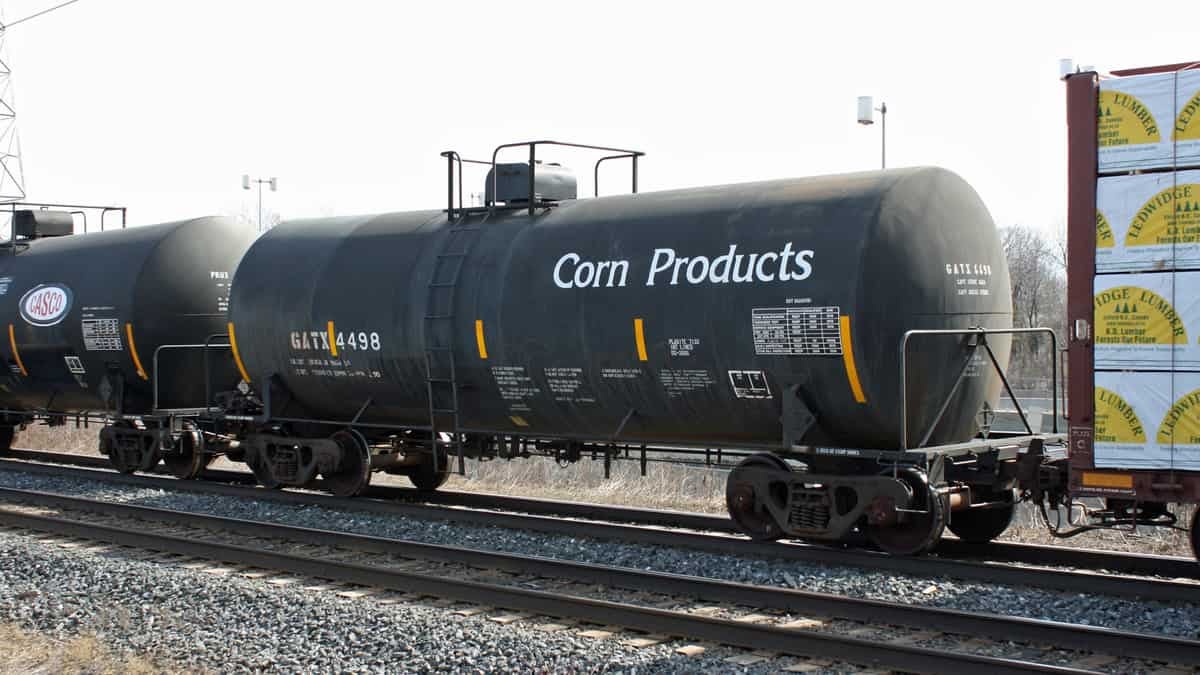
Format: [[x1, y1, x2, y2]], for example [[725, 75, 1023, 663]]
[[1097, 70, 1200, 173]]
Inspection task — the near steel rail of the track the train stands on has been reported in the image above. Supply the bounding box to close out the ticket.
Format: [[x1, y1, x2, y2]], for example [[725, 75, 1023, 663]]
[[0, 460, 1200, 603]]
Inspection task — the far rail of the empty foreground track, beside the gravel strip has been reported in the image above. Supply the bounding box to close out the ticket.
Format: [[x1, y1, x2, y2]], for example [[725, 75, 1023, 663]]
[[0, 488, 1200, 664]]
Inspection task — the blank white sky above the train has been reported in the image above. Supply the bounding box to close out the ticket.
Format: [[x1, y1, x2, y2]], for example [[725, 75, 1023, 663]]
[[4, 0, 1200, 231]]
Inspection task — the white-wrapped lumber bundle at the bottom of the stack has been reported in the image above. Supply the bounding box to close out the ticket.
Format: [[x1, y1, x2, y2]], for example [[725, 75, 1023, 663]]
[[1094, 371, 1200, 471]]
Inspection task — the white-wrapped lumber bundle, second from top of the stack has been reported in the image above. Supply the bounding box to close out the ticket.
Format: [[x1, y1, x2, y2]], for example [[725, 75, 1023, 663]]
[[1096, 171, 1200, 273]]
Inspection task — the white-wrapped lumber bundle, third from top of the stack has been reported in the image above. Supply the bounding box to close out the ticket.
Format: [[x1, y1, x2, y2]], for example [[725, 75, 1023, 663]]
[[1093, 271, 1200, 370]]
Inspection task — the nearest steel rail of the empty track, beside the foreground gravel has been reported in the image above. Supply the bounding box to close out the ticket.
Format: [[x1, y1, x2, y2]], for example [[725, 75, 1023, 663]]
[[0, 502, 1088, 674]]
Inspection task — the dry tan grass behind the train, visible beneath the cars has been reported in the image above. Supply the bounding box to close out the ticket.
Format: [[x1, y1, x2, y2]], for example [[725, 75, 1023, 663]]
[[9, 426, 1194, 556]]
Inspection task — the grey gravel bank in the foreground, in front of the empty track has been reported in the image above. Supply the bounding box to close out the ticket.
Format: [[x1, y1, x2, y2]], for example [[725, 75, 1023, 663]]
[[0, 532, 779, 673]]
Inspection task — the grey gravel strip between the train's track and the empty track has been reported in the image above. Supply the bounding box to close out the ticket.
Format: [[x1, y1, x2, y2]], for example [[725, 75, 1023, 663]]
[[0, 471, 1200, 639]]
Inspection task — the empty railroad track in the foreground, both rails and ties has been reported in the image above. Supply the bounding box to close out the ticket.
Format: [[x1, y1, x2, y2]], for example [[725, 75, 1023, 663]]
[[0, 489, 1200, 673]]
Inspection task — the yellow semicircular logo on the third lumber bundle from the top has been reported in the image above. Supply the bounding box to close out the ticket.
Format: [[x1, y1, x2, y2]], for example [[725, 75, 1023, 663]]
[[1096, 286, 1188, 345]]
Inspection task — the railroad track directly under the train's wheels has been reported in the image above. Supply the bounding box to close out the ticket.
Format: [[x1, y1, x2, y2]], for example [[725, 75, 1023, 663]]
[[0, 450, 1200, 603]]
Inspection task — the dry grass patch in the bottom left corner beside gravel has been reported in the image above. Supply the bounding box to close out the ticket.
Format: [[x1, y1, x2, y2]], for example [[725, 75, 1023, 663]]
[[0, 623, 169, 675]]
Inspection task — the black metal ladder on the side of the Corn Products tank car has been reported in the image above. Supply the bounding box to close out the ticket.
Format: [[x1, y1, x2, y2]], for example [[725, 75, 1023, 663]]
[[425, 216, 486, 473]]
